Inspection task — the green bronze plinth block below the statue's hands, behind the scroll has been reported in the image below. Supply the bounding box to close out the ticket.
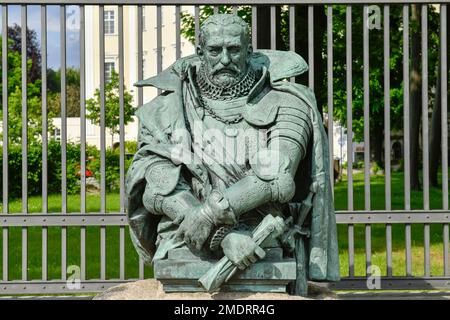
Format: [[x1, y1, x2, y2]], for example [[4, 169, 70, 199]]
[[154, 247, 296, 293]]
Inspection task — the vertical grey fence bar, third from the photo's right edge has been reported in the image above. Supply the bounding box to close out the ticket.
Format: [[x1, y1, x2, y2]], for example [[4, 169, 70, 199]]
[[403, 5, 412, 276]]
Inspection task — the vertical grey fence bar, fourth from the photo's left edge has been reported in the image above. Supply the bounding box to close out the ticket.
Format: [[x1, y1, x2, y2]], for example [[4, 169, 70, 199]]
[[60, 5, 67, 280]]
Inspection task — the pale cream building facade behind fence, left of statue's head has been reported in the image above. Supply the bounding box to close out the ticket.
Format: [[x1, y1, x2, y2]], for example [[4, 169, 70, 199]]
[[52, 6, 195, 148]]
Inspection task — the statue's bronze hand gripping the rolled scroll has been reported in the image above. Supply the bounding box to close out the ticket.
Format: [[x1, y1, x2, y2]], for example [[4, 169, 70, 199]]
[[221, 232, 266, 270]]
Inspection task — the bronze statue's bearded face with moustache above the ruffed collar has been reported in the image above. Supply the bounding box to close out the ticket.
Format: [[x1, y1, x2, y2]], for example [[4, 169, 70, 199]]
[[197, 24, 252, 87]]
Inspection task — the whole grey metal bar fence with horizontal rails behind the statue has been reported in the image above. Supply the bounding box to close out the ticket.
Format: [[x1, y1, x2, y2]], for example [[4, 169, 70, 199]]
[[0, 0, 450, 294]]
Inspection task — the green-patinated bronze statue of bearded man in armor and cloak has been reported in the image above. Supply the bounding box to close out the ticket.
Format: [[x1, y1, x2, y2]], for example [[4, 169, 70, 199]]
[[126, 14, 339, 293]]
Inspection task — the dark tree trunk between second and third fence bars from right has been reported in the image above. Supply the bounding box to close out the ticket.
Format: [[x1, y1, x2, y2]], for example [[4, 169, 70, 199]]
[[409, 4, 422, 190]]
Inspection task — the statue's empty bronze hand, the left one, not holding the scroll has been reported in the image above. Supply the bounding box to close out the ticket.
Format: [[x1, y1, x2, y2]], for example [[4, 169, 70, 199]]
[[175, 206, 214, 250]]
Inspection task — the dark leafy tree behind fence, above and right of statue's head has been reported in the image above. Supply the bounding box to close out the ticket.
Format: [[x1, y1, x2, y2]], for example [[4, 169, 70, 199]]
[[182, 5, 439, 174]]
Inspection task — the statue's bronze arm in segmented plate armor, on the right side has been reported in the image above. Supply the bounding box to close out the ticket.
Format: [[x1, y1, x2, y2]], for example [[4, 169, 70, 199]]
[[205, 99, 312, 224]]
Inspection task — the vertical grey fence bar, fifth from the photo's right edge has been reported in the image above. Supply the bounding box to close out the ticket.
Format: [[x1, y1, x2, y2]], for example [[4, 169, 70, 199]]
[[363, 5, 372, 274]]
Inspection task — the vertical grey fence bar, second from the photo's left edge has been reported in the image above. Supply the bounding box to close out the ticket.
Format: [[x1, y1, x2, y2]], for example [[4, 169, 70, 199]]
[[21, 5, 28, 281]]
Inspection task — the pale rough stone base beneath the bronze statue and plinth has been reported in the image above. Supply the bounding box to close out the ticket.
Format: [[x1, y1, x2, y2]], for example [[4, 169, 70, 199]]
[[94, 279, 337, 300]]
